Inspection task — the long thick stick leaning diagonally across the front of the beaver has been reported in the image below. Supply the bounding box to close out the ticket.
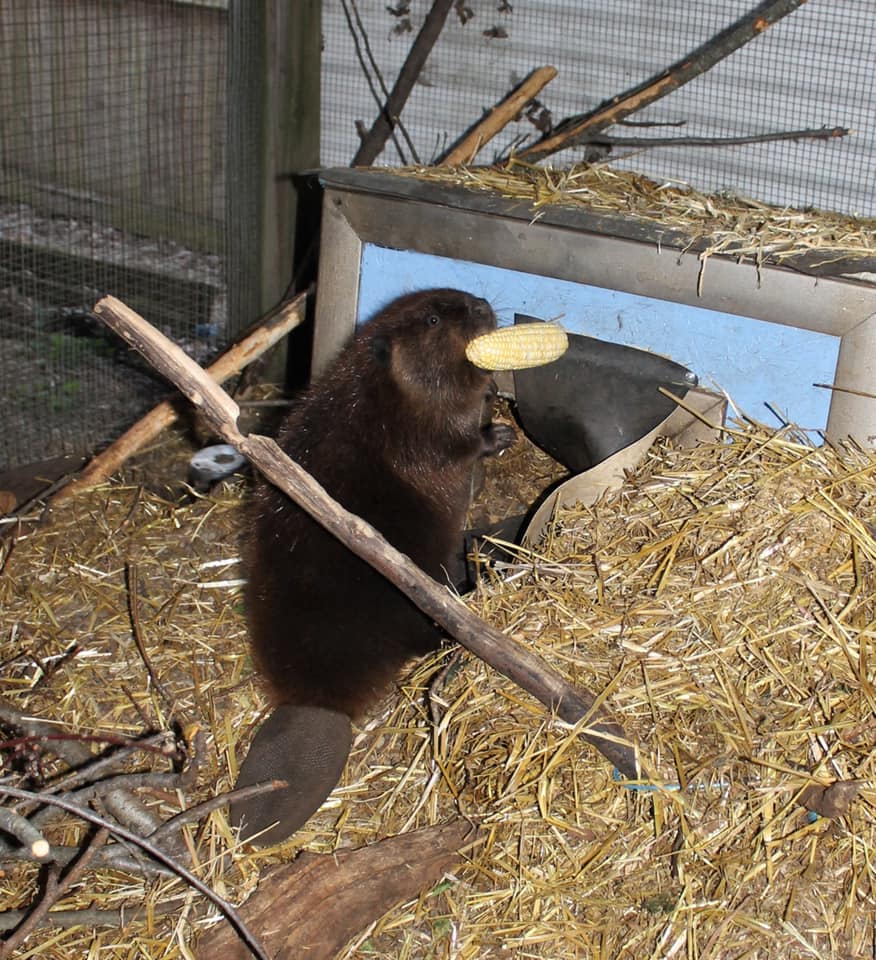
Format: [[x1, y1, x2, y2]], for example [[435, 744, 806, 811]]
[[94, 297, 641, 779]]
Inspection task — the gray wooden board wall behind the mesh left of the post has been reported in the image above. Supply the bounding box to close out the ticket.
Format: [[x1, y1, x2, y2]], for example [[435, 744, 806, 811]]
[[0, 0, 227, 252]]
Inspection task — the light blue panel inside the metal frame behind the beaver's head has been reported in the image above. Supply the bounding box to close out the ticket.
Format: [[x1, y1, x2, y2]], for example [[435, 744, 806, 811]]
[[359, 244, 839, 430]]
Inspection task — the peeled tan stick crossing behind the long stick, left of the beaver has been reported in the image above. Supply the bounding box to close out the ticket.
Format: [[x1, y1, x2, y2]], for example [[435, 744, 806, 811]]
[[52, 293, 307, 502]]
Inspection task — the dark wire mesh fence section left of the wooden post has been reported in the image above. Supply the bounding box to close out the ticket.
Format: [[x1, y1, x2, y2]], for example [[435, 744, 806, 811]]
[[0, 0, 226, 472]]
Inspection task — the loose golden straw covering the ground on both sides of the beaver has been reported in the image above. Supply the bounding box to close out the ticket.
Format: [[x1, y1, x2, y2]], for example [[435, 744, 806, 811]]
[[0, 424, 876, 960]]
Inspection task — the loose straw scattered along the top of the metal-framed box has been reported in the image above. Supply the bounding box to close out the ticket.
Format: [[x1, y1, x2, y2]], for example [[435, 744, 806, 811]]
[[392, 158, 876, 264]]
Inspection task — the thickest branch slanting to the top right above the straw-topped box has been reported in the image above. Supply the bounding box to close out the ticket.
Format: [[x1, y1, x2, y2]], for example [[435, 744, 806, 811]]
[[517, 0, 806, 162]]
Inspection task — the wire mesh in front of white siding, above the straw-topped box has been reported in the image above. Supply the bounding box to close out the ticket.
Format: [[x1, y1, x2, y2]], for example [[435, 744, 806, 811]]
[[322, 0, 876, 217]]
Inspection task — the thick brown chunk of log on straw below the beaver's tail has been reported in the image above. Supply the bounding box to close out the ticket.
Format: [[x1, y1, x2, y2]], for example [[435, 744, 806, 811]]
[[197, 818, 475, 960]]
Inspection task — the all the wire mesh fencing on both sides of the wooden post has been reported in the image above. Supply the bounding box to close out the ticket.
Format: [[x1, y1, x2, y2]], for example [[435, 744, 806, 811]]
[[0, 0, 876, 473]]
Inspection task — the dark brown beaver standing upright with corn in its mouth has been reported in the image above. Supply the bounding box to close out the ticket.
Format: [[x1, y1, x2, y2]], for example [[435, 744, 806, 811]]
[[231, 289, 516, 844]]
